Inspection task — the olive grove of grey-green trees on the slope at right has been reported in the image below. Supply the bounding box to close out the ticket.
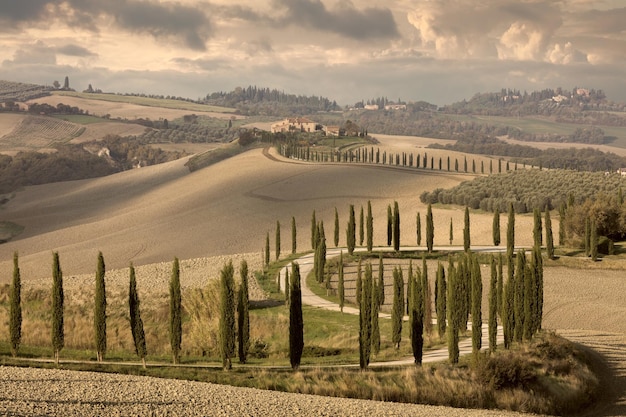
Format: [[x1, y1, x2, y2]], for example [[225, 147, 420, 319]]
[[420, 169, 622, 213]]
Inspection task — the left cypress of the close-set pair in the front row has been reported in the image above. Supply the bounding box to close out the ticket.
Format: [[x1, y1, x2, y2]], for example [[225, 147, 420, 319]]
[[220, 261, 235, 370]]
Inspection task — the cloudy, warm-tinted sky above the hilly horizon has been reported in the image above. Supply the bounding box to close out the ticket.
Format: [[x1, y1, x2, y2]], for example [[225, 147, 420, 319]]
[[0, 0, 626, 105]]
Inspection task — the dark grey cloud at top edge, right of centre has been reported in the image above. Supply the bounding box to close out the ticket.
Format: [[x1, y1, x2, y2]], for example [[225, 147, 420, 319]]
[[274, 0, 399, 40]]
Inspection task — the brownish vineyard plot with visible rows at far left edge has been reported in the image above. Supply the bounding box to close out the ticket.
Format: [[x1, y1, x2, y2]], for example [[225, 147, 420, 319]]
[[0, 116, 85, 150]]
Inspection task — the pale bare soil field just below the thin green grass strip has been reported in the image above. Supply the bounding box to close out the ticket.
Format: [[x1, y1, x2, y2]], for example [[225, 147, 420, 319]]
[[26, 95, 243, 120]]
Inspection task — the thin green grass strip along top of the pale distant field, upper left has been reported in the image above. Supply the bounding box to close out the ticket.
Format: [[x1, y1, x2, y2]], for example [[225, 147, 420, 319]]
[[52, 91, 236, 113]]
